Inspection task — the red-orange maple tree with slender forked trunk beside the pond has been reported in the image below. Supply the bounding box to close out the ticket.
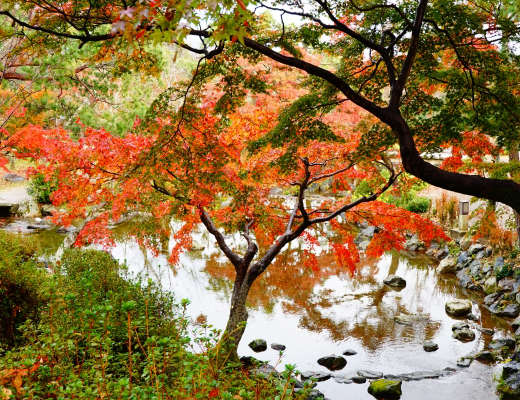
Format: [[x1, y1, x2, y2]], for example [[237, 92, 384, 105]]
[[8, 61, 449, 355]]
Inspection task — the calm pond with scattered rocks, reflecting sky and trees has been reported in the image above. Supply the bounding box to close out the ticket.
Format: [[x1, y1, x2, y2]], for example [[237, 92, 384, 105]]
[[4, 219, 510, 400]]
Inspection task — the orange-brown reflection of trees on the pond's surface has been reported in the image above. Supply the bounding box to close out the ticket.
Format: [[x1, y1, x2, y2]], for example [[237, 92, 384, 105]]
[[205, 242, 453, 350]]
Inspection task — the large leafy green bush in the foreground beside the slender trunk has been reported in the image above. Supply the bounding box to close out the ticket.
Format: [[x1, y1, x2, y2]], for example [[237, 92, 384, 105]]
[[0, 250, 310, 400]]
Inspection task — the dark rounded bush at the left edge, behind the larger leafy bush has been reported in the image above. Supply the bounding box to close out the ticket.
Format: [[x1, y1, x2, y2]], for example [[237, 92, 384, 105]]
[[0, 231, 48, 348]]
